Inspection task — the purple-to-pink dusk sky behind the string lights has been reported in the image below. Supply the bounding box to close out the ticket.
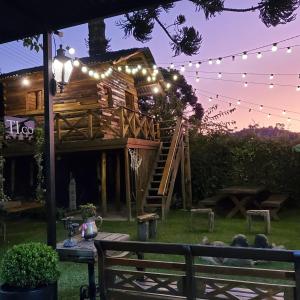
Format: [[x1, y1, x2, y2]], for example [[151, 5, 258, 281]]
[[0, 0, 300, 131]]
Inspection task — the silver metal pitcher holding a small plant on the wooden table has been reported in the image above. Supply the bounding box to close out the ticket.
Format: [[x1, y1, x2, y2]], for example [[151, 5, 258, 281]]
[[79, 203, 102, 240]]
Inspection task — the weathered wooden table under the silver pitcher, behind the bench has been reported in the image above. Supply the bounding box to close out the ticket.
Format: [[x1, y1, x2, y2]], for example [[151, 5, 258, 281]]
[[56, 232, 130, 300]]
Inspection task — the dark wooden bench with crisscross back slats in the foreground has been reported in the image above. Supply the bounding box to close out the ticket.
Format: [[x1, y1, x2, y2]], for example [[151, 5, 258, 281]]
[[95, 241, 300, 300]]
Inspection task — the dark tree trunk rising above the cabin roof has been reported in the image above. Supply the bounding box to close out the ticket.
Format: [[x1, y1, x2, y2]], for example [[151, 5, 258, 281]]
[[88, 18, 109, 57]]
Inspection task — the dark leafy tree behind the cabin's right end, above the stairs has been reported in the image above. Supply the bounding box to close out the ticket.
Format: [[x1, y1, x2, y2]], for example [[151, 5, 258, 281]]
[[139, 68, 204, 121]]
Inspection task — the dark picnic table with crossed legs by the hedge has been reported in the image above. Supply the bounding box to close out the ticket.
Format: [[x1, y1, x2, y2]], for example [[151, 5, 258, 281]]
[[219, 186, 266, 218]]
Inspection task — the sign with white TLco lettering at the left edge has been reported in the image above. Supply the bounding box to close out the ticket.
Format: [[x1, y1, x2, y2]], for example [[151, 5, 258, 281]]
[[4, 116, 35, 140]]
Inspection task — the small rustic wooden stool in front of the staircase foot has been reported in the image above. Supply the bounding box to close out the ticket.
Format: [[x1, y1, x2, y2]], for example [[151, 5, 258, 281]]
[[136, 213, 159, 241]]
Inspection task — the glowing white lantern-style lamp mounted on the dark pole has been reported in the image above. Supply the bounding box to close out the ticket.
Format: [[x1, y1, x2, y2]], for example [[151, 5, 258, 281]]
[[52, 45, 73, 93]]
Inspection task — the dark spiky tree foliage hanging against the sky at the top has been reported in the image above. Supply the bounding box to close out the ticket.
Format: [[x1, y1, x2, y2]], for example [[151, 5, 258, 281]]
[[24, 0, 300, 56]]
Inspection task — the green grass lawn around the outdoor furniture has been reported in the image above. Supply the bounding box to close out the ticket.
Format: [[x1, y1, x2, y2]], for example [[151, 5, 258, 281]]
[[0, 210, 300, 300]]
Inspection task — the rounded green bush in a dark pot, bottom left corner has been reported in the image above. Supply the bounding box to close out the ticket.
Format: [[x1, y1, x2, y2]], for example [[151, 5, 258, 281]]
[[0, 243, 59, 300]]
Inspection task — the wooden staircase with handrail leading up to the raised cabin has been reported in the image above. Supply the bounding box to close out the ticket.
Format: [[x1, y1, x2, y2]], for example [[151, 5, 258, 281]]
[[142, 118, 191, 219]]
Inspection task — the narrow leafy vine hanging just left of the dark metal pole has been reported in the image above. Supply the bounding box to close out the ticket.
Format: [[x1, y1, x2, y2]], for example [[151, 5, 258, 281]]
[[34, 127, 45, 202]]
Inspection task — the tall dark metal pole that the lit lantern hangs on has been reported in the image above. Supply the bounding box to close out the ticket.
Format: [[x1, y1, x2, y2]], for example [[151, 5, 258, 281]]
[[43, 32, 56, 249]]
